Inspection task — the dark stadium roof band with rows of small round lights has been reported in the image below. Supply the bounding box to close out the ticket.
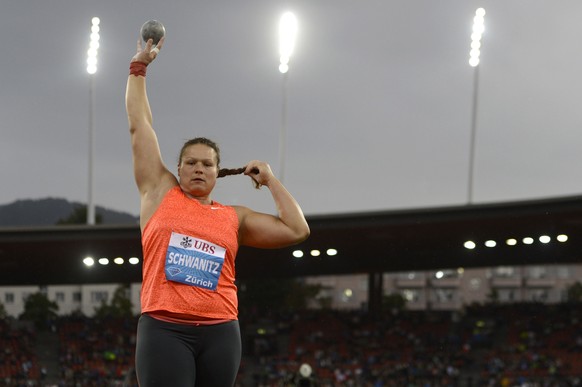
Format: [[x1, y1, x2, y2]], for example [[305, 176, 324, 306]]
[[0, 196, 582, 285]]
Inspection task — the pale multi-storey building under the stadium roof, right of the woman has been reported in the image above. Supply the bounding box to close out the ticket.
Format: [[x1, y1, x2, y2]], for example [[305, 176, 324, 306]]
[[305, 265, 582, 310]]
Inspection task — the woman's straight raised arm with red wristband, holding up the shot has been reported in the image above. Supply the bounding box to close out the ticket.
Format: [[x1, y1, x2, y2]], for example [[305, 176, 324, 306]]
[[125, 38, 177, 223]]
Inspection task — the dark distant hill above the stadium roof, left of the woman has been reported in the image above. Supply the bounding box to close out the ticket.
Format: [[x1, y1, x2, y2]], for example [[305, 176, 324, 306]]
[[0, 198, 139, 227]]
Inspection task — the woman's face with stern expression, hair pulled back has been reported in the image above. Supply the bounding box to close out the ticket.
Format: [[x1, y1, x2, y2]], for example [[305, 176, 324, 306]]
[[178, 144, 218, 197]]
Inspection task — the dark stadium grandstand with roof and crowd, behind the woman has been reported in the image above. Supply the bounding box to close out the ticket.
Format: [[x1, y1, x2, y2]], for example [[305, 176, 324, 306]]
[[0, 197, 582, 387]]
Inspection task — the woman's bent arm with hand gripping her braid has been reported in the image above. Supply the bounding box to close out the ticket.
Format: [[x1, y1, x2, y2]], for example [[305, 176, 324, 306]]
[[237, 161, 310, 248]]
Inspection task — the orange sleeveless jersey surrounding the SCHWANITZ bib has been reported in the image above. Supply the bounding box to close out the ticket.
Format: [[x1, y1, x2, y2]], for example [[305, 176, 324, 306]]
[[141, 186, 238, 320]]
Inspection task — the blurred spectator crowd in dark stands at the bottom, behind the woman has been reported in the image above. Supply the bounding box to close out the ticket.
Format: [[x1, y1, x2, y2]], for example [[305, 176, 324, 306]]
[[0, 303, 582, 387]]
